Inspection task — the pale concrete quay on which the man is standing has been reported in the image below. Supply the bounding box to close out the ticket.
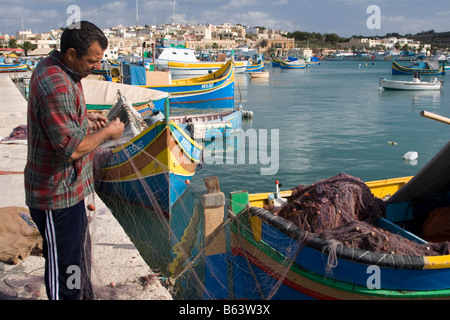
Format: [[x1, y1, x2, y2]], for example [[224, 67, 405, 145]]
[[0, 73, 172, 300]]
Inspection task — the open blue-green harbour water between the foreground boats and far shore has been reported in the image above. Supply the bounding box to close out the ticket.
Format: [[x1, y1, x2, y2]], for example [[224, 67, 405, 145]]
[[192, 61, 450, 196]]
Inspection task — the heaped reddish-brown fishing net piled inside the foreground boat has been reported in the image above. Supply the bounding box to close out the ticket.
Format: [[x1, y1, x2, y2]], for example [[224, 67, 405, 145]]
[[268, 173, 450, 256]]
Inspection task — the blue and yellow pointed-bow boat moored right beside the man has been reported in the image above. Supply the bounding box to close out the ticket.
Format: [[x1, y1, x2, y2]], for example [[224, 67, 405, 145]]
[[94, 94, 202, 213]]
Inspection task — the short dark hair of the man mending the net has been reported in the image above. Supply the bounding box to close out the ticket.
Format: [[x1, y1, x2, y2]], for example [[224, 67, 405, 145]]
[[61, 21, 108, 58]]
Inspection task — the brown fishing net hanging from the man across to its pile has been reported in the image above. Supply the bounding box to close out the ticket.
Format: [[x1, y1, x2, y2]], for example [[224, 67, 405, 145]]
[[81, 95, 449, 299]]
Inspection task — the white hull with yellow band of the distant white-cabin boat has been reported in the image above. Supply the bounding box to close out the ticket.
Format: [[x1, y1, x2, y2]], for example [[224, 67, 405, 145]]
[[167, 60, 248, 76]]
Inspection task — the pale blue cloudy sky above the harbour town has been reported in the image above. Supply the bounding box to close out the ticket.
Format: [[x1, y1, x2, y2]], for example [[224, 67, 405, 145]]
[[0, 0, 450, 37]]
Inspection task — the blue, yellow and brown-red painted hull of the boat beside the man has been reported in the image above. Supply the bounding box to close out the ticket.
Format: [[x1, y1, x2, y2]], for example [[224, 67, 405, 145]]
[[96, 122, 201, 212]]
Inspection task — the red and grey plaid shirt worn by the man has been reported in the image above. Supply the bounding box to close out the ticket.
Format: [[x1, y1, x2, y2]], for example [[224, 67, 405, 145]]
[[25, 50, 94, 210]]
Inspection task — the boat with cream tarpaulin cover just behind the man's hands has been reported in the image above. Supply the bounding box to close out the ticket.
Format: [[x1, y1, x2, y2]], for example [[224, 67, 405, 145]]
[[81, 78, 169, 118]]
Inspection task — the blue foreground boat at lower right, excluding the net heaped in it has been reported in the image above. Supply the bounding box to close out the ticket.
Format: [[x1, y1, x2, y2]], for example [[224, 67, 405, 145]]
[[225, 142, 450, 299]]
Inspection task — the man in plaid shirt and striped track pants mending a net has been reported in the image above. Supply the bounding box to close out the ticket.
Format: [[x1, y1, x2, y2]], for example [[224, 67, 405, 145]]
[[25, 21, 124, 300]]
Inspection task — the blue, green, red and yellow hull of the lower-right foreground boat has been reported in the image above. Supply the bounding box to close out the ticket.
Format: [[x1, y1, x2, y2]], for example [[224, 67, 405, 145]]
[[225, 172, 450, 300]]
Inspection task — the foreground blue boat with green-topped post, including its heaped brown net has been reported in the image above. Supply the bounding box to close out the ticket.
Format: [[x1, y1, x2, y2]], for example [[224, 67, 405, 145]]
[[225, 139, 450, 299]]
